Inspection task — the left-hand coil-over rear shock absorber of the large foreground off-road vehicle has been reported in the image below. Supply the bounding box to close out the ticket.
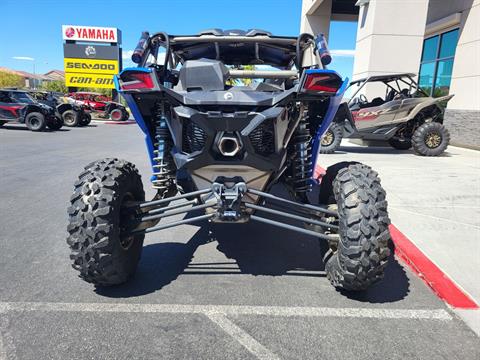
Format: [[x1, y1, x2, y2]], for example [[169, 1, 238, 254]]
[[152, 105, 175, 198]]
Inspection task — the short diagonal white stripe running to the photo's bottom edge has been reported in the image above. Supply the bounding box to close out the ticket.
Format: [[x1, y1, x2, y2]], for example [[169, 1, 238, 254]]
[[207, 313, 279, 360]]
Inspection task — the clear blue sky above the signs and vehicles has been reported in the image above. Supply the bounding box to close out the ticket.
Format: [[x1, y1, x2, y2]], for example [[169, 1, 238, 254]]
[[0, 0, 356, 78]]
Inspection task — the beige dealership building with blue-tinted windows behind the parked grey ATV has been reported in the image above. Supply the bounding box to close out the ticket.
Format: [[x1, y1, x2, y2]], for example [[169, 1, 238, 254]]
[[300, 0, 480, 147]]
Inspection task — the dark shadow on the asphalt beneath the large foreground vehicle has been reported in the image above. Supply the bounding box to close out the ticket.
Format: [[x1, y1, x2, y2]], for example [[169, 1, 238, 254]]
[[95, 201, 409, 303]]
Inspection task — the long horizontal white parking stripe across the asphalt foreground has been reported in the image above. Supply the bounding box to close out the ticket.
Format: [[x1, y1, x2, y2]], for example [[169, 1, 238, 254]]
[[0, 302, 452, 321]]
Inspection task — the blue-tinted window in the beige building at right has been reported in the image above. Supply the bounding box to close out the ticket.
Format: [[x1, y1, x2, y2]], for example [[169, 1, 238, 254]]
[[419, 29, 458, 97]]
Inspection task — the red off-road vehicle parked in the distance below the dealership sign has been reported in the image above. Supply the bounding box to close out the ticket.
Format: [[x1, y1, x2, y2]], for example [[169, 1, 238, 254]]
[[70, 92, 129, 121]]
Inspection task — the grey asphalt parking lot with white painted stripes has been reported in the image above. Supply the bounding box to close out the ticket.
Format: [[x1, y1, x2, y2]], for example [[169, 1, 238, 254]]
[[0, 123, 480, 359]]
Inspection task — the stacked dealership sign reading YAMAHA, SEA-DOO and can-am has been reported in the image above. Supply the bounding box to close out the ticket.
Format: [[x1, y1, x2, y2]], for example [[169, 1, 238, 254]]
[[62, 25, 122, 101]]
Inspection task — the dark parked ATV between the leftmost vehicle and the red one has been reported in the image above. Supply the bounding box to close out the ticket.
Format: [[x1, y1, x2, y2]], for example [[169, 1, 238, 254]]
[[29, 90, 92, 127]]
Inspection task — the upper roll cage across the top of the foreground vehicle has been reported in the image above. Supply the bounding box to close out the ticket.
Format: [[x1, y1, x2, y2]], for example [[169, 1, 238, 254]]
[[132, 29, 323, 78]]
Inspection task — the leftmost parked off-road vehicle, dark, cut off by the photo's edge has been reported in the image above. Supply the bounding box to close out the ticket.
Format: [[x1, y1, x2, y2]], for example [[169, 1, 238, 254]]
[[0, 89, 63, 131]]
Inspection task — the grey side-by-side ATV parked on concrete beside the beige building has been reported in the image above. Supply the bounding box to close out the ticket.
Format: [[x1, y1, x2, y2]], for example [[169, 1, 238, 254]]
[[320, 74, 453, 156]]
